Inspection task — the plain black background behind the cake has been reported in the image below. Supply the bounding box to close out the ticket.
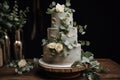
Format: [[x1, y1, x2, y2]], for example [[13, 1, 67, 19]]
[[4, 0, 120, 63]]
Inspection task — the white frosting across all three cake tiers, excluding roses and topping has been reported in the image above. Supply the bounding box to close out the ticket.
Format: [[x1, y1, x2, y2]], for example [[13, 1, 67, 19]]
[[42, 6, 81, 66]]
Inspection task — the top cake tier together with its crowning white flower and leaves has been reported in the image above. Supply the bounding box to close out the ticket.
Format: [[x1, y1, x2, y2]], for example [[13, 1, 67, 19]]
[[47, 3, 75, 29]]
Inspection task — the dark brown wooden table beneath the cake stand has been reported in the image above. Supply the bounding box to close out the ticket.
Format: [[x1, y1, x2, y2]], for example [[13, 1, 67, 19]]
[[0, 59, 120, 80]]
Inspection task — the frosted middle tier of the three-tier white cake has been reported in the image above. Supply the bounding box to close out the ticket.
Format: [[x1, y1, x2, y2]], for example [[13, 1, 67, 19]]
[[47, 27, 78, 44]]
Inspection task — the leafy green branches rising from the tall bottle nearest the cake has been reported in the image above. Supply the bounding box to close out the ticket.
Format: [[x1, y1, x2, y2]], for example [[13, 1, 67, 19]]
[[10, 1, 29, 30]]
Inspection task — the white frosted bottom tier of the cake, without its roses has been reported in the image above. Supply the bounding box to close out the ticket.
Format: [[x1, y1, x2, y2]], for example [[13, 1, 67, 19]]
[[43, 46, 81, 64]]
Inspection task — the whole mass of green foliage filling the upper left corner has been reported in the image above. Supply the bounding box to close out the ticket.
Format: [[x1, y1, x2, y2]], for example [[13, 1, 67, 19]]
[[0, 0, 29, 46]]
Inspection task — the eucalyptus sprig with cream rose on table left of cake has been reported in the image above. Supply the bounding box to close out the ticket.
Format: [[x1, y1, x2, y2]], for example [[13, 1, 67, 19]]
[[5, 58, 38, 75]]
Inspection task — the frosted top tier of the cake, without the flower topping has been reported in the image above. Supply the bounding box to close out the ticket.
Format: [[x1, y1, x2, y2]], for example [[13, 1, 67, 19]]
[[51, 11, 73, 28]]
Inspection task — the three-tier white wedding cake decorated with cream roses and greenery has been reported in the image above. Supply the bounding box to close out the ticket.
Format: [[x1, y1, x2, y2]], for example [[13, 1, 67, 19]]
[[42, 2, 81, 67]]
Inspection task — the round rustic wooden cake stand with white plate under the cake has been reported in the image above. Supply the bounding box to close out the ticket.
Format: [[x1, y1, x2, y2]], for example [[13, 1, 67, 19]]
[[39, 58, 87, 79]]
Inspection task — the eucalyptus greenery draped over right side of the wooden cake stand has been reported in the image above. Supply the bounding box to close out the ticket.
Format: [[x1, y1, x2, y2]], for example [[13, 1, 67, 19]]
[[72, 51, 101, 80]]
